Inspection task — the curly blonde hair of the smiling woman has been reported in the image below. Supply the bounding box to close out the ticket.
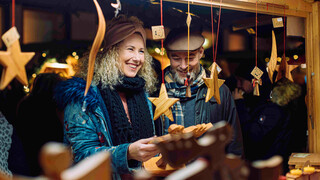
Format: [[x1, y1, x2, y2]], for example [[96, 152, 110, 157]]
[[75, 37, 157, 93]]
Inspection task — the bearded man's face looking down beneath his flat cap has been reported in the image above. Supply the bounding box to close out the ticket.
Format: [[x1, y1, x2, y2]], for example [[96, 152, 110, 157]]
[[168, 47, 204, 84]]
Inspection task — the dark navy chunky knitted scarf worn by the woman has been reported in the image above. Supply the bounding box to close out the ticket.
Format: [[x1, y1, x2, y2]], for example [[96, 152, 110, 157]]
[[98, 77, 153, 145]]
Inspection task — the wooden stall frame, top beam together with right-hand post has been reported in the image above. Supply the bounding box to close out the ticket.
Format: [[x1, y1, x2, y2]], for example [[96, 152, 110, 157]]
[[166, 0, 320, 153]]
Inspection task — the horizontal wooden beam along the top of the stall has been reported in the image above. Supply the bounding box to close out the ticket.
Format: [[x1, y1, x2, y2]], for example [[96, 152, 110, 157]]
[[165, 0, 312, 18]]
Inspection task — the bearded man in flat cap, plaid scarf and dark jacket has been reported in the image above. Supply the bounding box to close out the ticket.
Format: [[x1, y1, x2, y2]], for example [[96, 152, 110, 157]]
[[164, 27, 243, 156]]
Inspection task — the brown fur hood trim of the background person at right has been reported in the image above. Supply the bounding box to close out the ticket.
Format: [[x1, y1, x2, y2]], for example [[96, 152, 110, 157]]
[[271, 78, 301, 106]]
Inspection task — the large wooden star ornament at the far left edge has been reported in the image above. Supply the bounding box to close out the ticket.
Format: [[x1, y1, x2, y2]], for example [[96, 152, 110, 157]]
[[0, 40, 35, 90]]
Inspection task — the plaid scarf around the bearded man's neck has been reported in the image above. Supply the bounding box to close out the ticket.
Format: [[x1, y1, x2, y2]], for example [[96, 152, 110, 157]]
[[164, 66, 206, 126]]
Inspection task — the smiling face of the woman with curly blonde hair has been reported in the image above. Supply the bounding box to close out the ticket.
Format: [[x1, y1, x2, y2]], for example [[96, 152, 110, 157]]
[[119, 33, 145, 77]]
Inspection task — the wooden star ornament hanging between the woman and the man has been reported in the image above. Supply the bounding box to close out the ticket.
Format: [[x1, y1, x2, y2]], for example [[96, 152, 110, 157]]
[[148, 83, 179, 121]]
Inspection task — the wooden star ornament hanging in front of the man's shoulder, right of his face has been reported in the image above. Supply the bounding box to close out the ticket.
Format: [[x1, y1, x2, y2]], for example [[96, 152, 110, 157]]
[[202, 62, 224, 104]]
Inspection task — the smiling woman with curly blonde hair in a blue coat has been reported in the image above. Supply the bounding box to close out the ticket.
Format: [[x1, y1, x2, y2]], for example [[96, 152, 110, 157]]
[[56, 16, 159, 179]]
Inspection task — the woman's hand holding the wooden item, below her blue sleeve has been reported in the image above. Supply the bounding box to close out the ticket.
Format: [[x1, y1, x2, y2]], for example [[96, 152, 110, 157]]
[[128, 137, 159, 162]]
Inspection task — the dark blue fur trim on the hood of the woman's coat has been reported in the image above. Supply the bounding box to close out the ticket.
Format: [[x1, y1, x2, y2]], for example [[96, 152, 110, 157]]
[[54, 77, 98, 111]]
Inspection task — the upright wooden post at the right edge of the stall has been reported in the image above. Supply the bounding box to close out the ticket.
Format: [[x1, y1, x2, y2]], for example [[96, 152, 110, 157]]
[[306, 2, 320, 153]]
